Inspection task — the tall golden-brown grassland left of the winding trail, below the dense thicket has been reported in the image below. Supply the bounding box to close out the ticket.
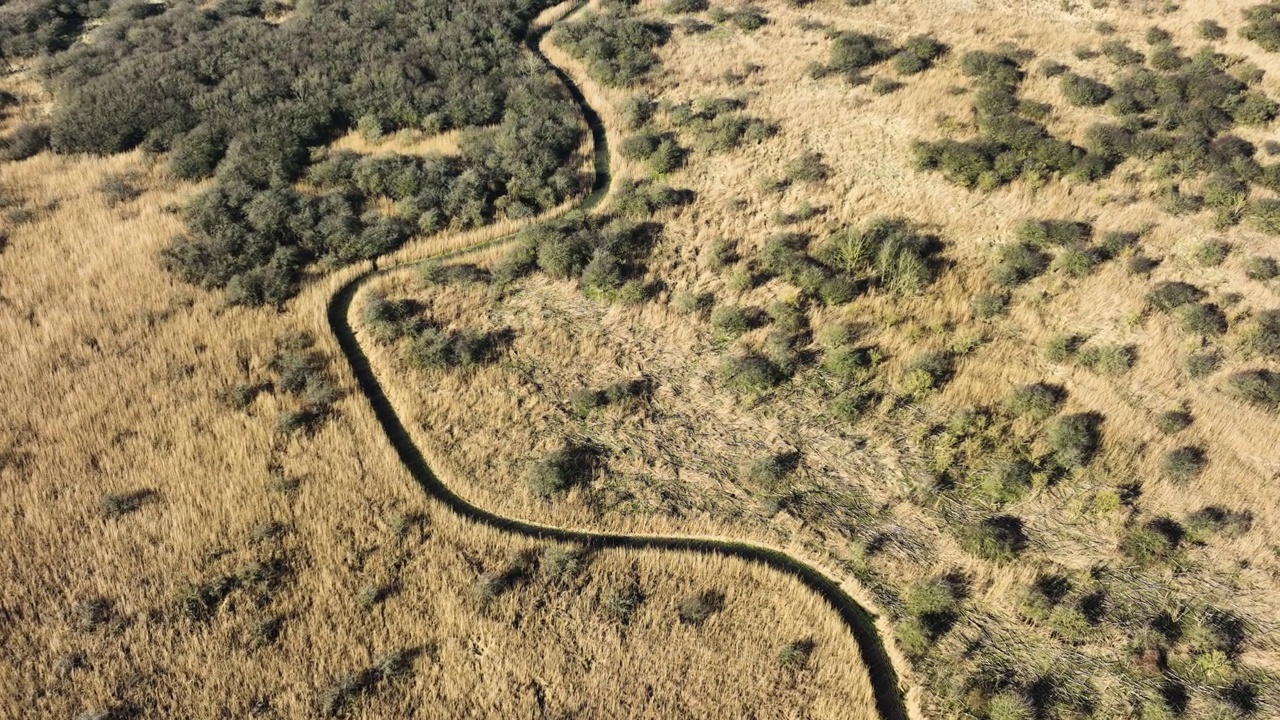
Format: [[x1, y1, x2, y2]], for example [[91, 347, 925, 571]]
[[0, 15, 874, 719]]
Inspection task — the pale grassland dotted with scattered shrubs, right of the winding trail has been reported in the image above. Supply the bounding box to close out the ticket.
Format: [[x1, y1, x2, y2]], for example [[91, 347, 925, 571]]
[[356, 1, 1280, 719]]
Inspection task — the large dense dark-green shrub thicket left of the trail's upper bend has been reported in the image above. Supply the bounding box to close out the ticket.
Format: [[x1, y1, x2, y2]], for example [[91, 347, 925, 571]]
[[6, 0, 581, 305]]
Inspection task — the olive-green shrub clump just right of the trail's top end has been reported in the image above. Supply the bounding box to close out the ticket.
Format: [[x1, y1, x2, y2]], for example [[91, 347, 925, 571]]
[[556, 12, 671, 87]]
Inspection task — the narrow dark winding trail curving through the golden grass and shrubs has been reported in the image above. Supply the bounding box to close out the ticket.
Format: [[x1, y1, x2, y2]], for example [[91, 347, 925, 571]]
[[326, 3, 910, 720]]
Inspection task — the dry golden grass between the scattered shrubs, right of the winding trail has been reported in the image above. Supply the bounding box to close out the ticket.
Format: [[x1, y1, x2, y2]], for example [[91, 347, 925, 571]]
[[356, 0, 1280, 716]]
